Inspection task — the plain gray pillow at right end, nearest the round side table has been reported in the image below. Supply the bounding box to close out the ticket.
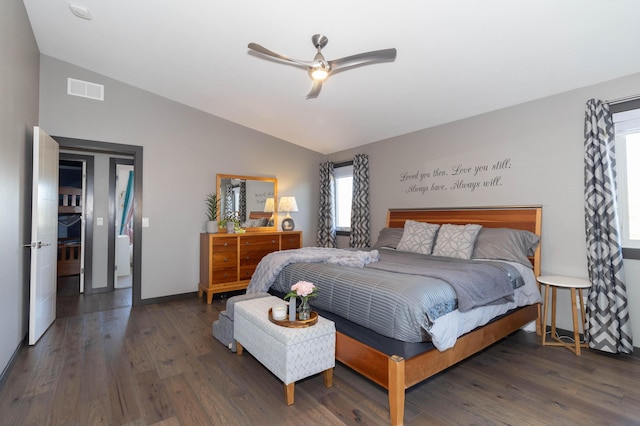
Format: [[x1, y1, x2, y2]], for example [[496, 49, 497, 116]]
[[473, 228, 540, 268]]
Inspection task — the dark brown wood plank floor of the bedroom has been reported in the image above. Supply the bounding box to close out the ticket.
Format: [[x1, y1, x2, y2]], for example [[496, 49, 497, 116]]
[[0, 296, 640, 425]]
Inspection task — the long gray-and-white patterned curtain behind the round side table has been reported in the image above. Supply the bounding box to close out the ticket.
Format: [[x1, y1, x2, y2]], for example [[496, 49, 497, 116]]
[[584, 99, 633, 354]]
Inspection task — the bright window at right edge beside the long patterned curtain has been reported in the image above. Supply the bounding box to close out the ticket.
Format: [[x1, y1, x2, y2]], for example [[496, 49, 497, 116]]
[[611, 101, 640, 253]]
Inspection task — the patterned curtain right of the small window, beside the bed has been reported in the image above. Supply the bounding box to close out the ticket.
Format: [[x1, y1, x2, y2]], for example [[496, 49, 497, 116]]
[[349, 154, 371, 248]]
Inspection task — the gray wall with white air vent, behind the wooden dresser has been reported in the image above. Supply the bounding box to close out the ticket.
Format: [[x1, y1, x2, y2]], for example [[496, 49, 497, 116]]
[[40, 56, 323, 299]]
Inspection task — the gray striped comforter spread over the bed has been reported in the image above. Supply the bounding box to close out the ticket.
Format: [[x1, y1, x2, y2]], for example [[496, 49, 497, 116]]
[[247, 246, 522, 342]]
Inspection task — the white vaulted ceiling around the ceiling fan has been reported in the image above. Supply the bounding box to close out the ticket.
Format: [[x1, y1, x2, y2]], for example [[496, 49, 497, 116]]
[[24, 0, 640, 154]]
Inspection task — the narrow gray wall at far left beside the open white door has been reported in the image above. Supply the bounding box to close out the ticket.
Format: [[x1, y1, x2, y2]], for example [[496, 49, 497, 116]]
[[0, 0, 40, 372]]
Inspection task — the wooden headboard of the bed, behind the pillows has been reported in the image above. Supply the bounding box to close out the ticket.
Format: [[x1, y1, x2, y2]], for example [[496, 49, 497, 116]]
[[387, 206, 542, 277]]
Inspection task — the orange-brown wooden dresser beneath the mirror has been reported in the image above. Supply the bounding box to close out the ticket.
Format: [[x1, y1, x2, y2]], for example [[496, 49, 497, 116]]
[[198, 231, 302, 304]]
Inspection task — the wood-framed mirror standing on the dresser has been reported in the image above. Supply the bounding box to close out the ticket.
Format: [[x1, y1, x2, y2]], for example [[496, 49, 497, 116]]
[[216, 174, 278, 231]]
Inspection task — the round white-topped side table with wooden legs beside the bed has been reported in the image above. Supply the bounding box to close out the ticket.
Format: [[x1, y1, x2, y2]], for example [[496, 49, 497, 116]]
[[538, 275, 591, 356]]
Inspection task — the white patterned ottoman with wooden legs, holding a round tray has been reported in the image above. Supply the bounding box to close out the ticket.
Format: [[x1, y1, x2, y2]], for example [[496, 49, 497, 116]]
[[234, 296, 336, 405]]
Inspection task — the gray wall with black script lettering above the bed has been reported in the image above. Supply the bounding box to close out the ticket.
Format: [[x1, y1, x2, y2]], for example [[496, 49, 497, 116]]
[[329, 74, 640, 340]]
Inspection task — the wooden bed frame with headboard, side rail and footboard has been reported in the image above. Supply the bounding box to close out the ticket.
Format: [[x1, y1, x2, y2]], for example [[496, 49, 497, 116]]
[[336, 206, 542, 425]]
